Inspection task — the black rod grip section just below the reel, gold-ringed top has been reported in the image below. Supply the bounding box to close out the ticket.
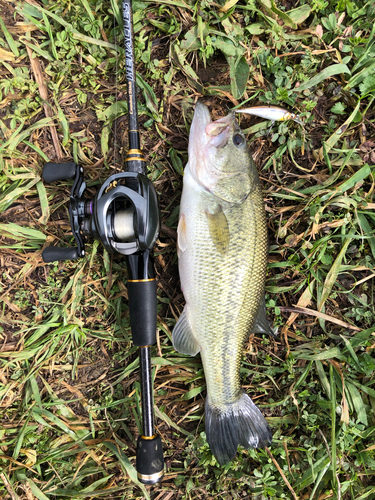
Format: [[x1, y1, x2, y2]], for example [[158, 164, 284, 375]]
[[128, 279, 157, 347]]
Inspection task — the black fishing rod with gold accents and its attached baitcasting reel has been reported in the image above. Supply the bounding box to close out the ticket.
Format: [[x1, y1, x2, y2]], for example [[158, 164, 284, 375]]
[[42, 0, 164, 484]]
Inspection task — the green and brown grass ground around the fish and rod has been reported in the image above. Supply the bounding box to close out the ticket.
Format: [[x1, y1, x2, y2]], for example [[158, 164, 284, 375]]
[[0, 0, 375, 500]]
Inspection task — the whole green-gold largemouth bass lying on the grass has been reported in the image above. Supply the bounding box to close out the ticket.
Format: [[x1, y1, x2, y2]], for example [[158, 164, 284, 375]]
[[173, 102, 273, 464]]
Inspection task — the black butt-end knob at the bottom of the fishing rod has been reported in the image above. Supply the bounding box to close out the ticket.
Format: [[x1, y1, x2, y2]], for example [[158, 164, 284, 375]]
[[136, 434, 164, 484]]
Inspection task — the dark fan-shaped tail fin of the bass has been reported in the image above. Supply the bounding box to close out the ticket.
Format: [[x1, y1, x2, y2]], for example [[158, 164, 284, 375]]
[[206, 393, 272, 465]]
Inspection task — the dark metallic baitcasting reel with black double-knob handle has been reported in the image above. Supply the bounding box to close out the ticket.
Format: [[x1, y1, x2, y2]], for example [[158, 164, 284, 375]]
[[42, 159, 160, 262]]
